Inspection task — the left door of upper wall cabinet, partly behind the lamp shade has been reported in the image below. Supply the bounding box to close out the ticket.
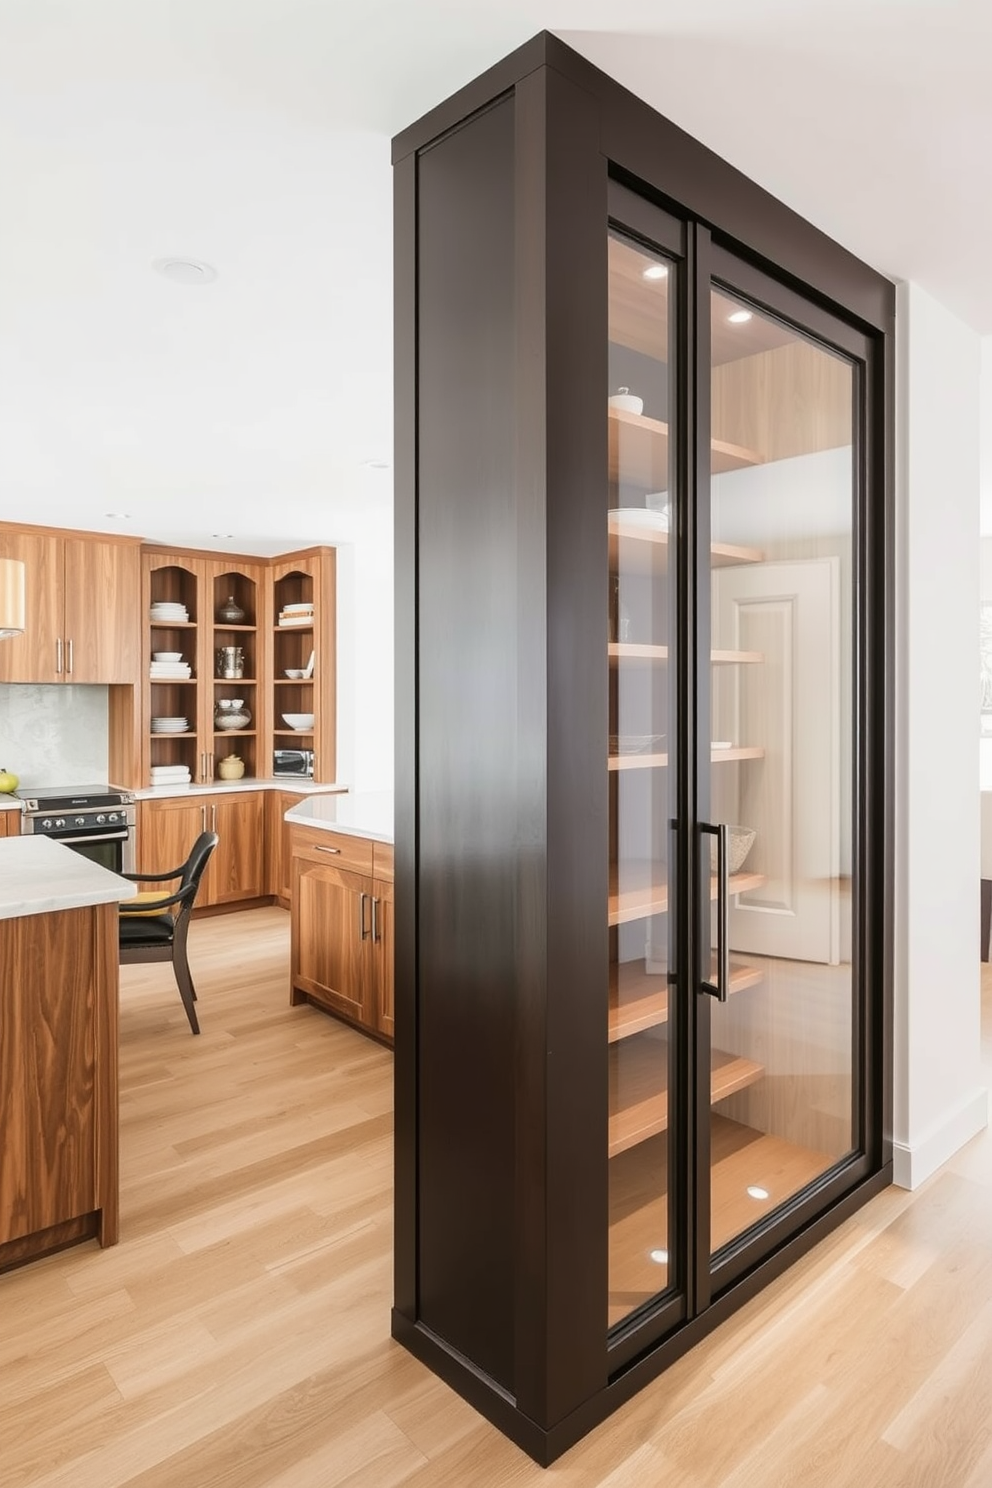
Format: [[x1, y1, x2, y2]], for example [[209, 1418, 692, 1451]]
[[0, 524, 60, 682]]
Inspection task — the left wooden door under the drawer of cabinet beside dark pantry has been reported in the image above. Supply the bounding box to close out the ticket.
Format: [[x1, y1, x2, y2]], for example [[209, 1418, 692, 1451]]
[[292, 854, 375, 1025]]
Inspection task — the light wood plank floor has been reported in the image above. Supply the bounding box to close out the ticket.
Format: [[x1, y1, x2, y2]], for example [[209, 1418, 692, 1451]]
[[0, 909, 992, 1488]]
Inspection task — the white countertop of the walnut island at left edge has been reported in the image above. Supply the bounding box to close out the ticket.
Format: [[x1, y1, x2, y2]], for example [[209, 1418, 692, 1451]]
[[0, 836, 138, 920]]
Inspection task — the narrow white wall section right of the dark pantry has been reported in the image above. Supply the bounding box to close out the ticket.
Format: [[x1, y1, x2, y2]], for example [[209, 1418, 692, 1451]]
[[892, 276, 988, 1187]]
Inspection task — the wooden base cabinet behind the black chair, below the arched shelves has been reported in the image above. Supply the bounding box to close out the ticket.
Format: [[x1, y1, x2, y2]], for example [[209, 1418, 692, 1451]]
[[137, 790, 268, 909]]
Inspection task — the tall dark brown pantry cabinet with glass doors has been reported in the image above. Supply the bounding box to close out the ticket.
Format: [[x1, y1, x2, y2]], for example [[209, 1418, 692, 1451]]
[[392, 34, 894, 1463]]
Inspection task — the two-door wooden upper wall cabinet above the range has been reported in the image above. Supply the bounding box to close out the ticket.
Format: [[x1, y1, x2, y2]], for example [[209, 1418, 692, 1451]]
[[0, 522, 140, 686]]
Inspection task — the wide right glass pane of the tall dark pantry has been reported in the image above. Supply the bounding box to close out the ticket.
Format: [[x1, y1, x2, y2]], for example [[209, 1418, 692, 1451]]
[[703, 289, 855, 1253]]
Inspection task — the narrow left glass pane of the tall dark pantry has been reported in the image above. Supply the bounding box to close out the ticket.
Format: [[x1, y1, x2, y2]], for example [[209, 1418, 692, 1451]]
[[607, 234, 677, 1326]]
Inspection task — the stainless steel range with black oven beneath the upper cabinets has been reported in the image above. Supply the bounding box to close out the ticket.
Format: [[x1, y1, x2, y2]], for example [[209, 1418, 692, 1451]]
[[15, 786, 137, 873]]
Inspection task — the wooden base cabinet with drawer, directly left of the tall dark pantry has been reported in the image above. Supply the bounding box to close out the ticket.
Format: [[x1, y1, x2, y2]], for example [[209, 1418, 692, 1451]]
[[290, 826, 394, 1043]]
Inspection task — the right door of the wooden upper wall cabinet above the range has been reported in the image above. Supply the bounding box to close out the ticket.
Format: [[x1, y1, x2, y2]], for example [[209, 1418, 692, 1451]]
[[61, 537, 143, 686]]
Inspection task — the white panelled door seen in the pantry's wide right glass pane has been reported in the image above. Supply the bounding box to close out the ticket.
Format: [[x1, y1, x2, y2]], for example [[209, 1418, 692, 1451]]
[[712, 557, 840, 964]]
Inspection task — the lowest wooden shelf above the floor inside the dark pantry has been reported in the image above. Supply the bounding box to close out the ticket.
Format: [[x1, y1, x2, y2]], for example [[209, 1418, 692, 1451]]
[[610, 1036, 764, 1158]]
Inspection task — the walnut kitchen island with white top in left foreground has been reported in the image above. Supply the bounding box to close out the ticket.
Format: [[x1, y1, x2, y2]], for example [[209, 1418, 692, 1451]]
[[0, 836, 135, 1271]]
